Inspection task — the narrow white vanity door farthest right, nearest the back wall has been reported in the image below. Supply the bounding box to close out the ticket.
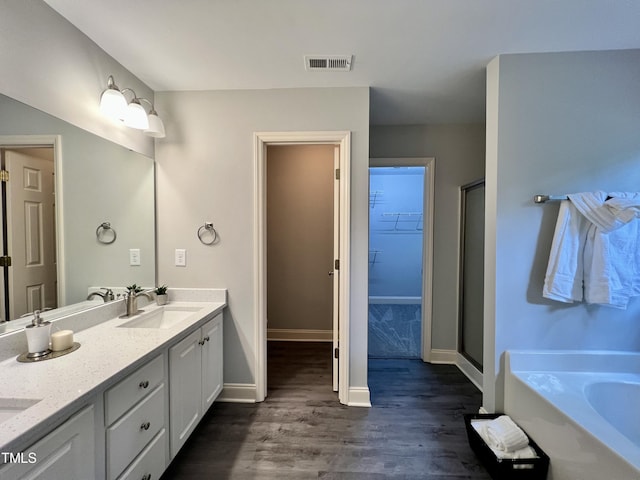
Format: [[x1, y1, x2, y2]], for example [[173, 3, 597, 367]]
[[202, 313, 222, 413]]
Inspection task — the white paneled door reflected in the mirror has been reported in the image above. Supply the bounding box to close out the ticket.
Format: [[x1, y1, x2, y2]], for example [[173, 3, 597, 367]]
[[5, 148, 57, 319]]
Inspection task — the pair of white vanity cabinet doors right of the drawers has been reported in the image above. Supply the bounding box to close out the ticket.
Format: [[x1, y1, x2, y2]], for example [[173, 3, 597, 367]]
[[169, 313, 223, 458]]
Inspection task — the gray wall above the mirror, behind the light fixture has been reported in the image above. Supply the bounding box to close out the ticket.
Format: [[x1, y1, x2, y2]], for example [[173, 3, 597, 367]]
[[0, 0, 154, 155]]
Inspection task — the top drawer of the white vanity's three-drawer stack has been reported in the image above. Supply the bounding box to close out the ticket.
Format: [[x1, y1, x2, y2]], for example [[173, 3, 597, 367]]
[[105, 355, 164, 425]]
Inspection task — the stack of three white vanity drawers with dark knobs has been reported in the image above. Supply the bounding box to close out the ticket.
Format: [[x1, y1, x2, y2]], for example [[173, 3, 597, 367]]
[[105, 355, 167, 480]]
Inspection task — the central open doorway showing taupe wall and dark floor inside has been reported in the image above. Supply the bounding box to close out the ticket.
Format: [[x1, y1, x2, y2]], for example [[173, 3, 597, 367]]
[[266, 144, 335, 395]]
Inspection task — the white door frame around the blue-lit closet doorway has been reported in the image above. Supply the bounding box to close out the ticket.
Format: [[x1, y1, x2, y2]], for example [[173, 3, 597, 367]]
[[369, 157, 436, 362]]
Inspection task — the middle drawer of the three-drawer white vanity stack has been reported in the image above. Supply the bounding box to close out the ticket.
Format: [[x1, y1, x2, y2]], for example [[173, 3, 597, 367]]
[[107, 383, 164, 479]]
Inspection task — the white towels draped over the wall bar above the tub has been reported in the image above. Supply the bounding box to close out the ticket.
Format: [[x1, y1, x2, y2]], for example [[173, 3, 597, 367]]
[[543, 192, 640, 308]]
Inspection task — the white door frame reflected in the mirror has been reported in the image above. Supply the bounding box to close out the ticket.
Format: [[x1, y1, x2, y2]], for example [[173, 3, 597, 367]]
[[0, 135, 67, 307]]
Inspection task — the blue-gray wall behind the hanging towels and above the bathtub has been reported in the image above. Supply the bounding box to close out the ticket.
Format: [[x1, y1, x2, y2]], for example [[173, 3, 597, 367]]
[[483, 50, 640, 411]]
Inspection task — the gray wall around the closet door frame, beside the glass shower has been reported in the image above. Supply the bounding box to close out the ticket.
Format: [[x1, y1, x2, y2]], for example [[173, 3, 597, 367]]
[[370, 125, 485, 351]]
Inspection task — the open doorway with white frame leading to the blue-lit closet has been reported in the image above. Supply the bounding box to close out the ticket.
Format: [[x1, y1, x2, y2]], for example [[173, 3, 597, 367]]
[[368, 158, 433, 361]]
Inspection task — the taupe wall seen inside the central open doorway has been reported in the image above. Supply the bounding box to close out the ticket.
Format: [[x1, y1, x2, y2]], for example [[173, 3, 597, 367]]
[[267, 145, 335, 331]]
